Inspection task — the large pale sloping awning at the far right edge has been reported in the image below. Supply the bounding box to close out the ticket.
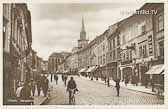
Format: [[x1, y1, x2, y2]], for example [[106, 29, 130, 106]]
[[146, 64, 164, 74]]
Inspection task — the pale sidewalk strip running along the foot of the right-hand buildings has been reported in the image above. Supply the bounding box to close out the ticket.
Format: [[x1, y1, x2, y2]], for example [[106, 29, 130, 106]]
[[80, 76, 156, 95]]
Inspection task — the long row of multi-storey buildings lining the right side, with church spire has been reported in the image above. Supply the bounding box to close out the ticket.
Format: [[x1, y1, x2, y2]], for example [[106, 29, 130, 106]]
[[49, 3, 164, 84]]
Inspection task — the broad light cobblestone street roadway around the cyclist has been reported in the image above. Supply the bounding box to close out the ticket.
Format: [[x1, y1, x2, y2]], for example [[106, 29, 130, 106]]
[[47, 76, 164, 105]]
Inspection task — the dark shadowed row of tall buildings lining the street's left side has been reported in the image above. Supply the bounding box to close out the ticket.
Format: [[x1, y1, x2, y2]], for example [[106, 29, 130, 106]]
[[3, 3, 48, 104]]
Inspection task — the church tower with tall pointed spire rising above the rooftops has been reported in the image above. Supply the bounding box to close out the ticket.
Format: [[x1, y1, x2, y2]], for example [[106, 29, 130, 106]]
[[78, 17, 89, 48]]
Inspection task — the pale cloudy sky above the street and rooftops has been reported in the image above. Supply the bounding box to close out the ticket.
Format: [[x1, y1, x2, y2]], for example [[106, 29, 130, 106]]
[[28, 2, 149, 60]]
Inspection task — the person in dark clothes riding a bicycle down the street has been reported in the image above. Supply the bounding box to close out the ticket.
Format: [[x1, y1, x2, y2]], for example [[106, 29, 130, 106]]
[[67, 77, 79, 104]]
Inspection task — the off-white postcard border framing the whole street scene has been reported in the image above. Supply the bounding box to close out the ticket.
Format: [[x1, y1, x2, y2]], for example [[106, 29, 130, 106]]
[[0, 0, 168, 109]]
